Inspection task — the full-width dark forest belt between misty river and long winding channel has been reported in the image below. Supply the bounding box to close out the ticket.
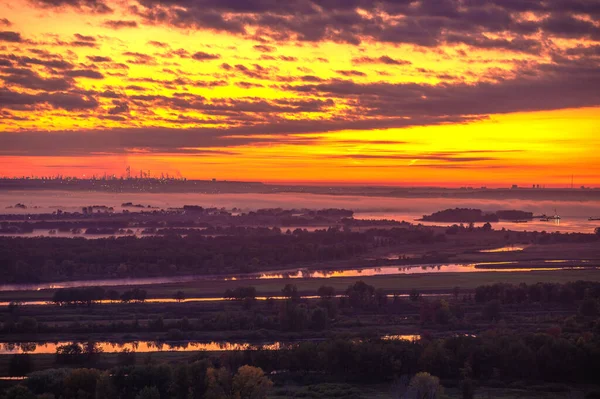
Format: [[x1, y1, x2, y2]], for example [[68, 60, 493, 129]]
[[0, 224, 600, 284]]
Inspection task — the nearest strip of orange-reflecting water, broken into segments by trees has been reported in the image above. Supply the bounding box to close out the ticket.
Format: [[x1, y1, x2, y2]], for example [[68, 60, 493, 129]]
[[0, 335, 421, 355]]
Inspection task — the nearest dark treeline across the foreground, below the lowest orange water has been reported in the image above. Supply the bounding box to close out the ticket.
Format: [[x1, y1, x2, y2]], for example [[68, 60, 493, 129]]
[[5, 330, 600, 399]]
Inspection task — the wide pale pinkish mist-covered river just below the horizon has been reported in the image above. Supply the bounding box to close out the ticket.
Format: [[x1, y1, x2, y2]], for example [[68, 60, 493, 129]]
[[0, 191, 600, 234]]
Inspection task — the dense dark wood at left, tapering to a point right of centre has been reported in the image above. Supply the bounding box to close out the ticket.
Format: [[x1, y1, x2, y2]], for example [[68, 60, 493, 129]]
[[0, 229, 376, 283]]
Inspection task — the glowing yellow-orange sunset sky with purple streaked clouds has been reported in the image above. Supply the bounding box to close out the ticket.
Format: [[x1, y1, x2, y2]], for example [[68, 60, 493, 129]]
[[0, 0, 600, 187]]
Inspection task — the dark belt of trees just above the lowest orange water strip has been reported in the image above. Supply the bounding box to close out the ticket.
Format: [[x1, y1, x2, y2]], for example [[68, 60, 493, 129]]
[[7, 281, 600, 341]]
